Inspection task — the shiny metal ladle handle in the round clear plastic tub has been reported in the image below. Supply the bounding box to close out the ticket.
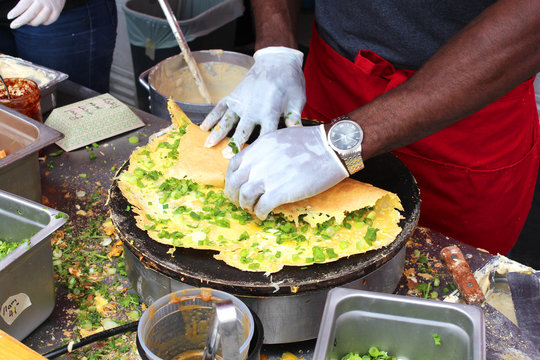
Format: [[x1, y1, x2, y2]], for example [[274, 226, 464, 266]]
[[202, 299, 240, 360]]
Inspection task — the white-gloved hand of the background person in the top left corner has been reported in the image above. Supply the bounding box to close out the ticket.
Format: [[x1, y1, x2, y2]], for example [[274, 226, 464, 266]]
[[7, 0, 66, 29]]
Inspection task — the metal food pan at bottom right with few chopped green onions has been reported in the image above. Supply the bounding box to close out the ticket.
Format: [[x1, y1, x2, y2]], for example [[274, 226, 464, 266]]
[[313, 288, 486, 360]]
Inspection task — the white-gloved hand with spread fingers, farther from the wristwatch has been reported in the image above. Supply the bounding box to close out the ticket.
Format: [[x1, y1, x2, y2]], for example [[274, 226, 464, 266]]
[[201, 47, 306, 158]]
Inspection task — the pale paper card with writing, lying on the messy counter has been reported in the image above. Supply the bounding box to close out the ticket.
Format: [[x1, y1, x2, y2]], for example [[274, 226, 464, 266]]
[[45, 94, 144, 151]]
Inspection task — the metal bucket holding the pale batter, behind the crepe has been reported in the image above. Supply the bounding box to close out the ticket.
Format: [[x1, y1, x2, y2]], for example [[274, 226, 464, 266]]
[[139, 50, 254, 124]]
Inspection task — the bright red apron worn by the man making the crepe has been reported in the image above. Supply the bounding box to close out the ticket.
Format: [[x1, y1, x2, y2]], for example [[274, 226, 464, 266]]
[[302, 27, 540, 254]]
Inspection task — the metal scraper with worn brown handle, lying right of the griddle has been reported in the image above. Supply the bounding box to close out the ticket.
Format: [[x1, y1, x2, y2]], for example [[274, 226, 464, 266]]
[[440, 245, 540, 360]]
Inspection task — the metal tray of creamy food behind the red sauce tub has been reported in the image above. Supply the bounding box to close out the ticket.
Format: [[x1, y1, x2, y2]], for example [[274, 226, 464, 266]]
[[0, 54, 68, 113]]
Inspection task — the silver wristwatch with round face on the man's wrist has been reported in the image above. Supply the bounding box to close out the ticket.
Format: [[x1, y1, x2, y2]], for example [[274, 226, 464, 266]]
[[328, 116, 364, 175]]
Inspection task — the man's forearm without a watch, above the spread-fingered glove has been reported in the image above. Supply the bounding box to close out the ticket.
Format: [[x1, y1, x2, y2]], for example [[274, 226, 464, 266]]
[[251, 0, 300, 50]]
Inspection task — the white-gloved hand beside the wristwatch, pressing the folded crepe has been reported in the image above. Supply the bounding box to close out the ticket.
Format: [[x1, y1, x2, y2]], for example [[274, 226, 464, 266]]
[[225, 125, 349, 219]]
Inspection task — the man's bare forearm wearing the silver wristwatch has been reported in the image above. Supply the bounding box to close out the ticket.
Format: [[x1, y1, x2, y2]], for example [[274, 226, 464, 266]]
[[350, 0, 540, 158]]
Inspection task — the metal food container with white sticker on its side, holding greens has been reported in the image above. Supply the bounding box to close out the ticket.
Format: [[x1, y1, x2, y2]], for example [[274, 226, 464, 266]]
[[0, 190, 67, 340]]
